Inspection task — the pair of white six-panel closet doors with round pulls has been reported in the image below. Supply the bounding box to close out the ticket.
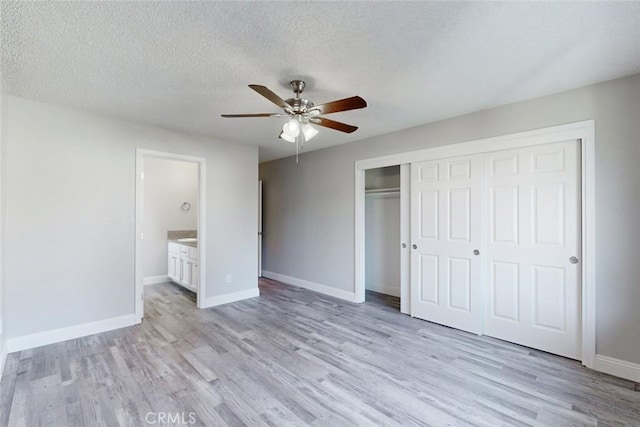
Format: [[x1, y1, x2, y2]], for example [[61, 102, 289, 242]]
[[411, 141, 582, 359]]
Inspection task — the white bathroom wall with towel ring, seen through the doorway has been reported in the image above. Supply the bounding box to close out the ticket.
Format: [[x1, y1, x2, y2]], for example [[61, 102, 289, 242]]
[[142, 157, 198, 277]]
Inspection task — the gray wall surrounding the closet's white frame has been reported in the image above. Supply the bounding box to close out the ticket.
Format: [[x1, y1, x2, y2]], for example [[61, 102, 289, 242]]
[[260, 75, 640, 363]]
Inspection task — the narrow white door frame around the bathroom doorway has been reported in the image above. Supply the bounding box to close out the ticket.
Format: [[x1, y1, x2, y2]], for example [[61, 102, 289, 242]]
[[134, 148, 207, 322]]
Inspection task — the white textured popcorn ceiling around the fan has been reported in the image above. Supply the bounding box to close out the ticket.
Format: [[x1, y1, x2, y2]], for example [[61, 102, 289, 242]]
[[2, 2, 640, 160]]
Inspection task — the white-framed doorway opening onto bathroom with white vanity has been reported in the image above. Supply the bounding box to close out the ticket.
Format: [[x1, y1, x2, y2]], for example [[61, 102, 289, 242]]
[[134, 149, 206, 320]]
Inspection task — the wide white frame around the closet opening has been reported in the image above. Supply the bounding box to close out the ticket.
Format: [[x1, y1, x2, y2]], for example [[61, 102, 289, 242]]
[[355, 120, 596, 369]]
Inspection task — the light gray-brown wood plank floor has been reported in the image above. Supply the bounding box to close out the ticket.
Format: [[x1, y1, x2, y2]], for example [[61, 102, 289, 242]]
[[0, 280, 640, 427]]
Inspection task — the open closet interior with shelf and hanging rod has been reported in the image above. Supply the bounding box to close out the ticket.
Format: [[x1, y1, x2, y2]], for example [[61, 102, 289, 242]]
[[365, 166, 400, 302]]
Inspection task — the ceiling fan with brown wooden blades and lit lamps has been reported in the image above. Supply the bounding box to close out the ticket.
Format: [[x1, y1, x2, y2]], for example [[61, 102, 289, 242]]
[[222, 80, 367, 155]]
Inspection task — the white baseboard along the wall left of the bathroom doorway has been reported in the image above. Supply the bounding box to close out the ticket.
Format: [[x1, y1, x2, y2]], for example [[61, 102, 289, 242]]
[[6, 314, 140, 353]]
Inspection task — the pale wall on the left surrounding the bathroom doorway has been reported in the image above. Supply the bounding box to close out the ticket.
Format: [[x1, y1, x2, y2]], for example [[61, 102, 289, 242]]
[[2, 97, 258, 339]]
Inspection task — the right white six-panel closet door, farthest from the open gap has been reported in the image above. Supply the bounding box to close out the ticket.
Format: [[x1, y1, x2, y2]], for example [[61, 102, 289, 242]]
[[483, 141, 581, 359]]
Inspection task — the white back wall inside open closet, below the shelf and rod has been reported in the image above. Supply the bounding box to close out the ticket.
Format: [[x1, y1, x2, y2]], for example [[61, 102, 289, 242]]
[[365, 196, 400, 297]]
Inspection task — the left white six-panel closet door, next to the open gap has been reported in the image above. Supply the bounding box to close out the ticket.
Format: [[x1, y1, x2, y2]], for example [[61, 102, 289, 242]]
[[411, 155, 482, 334]]
